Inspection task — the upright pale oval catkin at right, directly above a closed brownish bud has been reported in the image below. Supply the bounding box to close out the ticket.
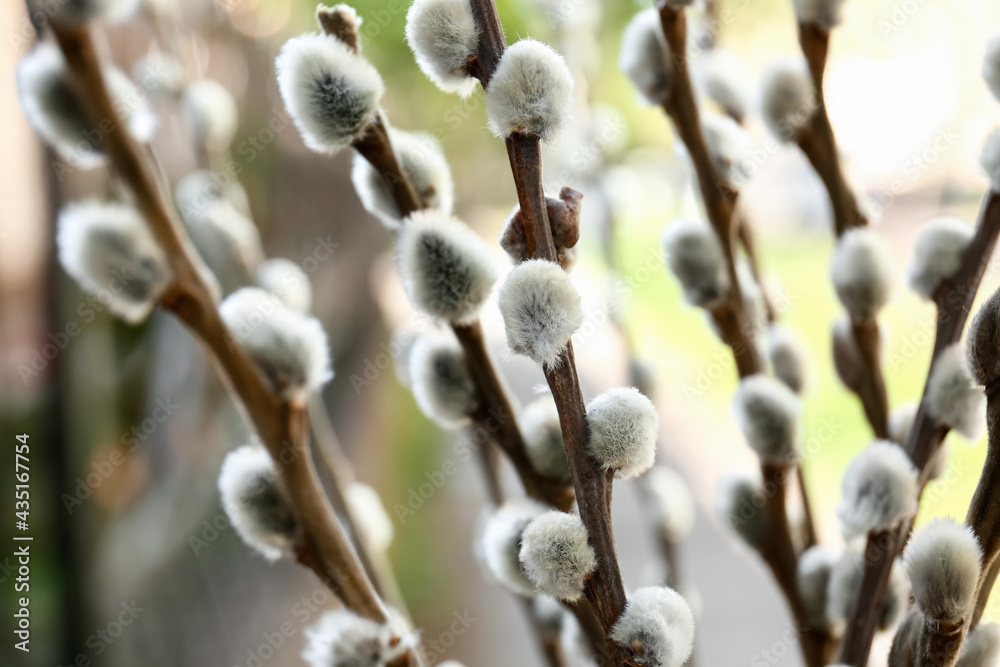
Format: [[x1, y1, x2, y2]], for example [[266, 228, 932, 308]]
[[830, 227, 892, 321]]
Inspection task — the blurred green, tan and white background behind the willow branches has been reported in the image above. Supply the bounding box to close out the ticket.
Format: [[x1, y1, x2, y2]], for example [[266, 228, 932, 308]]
[[0, 0, 1000, 667]]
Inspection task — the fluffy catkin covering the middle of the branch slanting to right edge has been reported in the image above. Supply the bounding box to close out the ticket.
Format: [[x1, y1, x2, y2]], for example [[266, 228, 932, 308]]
[[837, 440, 917, 537]]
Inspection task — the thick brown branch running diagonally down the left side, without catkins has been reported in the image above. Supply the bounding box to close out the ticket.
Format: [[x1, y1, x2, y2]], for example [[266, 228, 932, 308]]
[[52, 24, 385, 621]]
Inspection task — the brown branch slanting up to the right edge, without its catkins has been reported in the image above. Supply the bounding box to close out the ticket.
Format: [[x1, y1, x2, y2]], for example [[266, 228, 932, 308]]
[[839, 192, 1000, 667]]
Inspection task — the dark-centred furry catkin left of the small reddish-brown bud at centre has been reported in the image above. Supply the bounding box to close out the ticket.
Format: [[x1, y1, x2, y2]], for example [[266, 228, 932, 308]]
[[396, 210, 497, 323]]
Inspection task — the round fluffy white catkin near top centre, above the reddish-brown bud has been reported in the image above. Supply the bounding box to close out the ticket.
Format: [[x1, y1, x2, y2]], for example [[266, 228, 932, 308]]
[[486, 39, 573, 141]]
